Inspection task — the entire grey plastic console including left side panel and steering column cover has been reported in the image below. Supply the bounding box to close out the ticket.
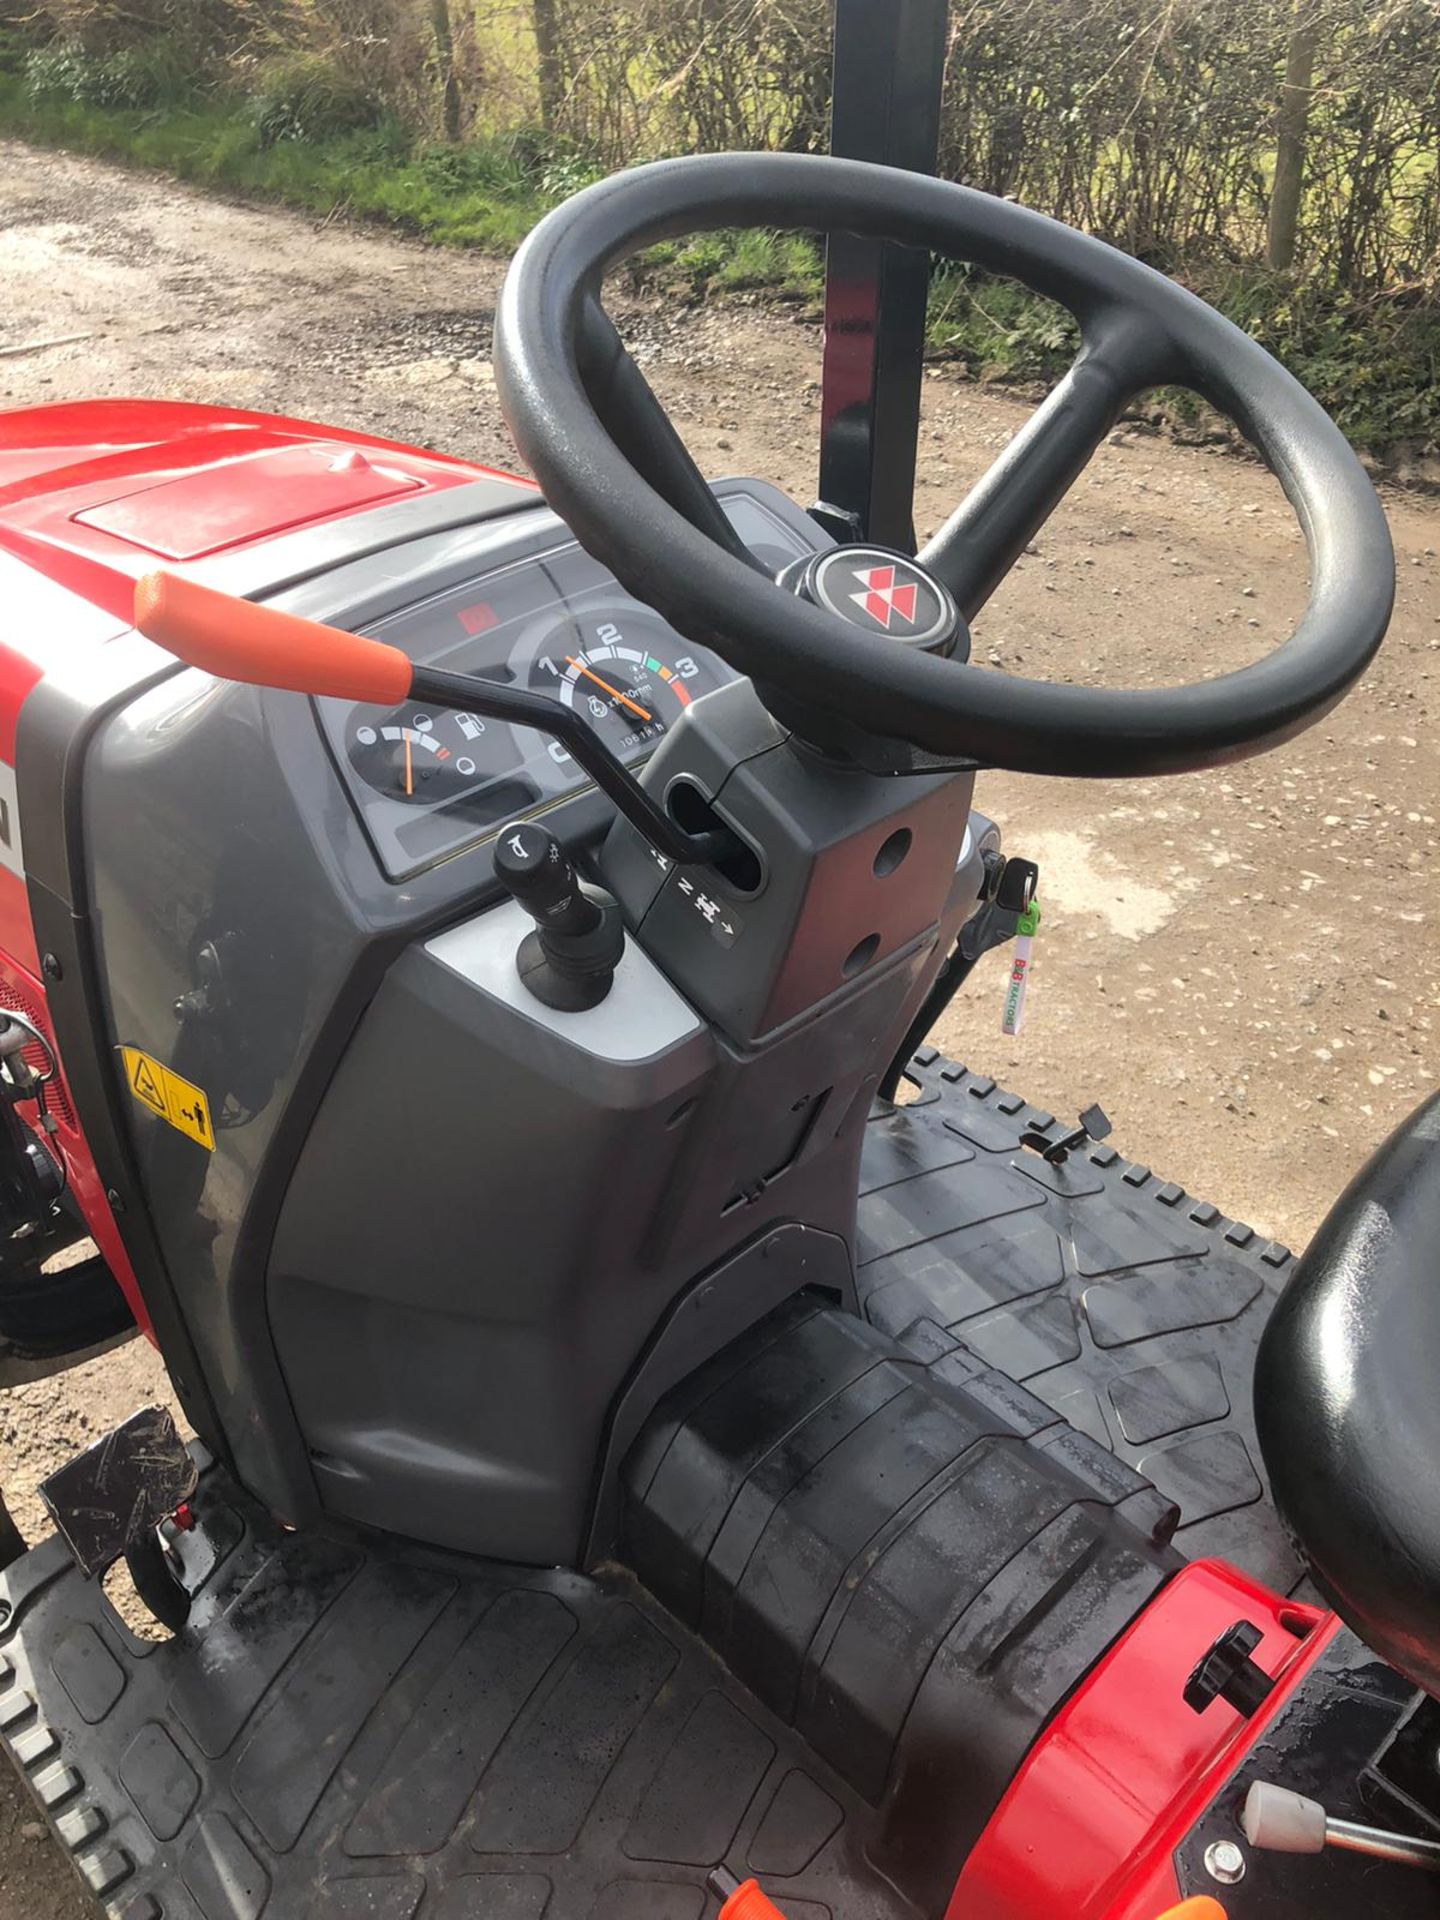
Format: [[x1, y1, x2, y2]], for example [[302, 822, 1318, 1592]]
[[58, 482, 1006, 1563]]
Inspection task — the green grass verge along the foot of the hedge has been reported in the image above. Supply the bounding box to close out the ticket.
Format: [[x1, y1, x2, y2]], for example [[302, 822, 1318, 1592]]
[[0, 68, 1440, 457]]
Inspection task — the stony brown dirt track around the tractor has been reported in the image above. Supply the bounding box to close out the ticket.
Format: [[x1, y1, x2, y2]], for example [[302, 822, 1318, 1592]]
[[0, 144, 1440, 1920]]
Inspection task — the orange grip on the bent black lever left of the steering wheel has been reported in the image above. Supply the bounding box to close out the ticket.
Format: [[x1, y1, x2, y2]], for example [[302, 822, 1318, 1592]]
[[134, 568, 415, 707]]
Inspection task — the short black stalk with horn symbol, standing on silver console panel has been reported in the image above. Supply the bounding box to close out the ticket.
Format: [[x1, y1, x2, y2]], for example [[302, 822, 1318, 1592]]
[[495, 820, 626, 1014]]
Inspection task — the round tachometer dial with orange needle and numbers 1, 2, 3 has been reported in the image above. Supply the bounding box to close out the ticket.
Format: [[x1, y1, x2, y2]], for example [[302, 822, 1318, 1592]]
[[530, 607, 720, 756]]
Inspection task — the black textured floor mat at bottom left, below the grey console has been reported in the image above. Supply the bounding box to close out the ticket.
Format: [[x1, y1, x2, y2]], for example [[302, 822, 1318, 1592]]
[[0, 1471, 925, 1920]]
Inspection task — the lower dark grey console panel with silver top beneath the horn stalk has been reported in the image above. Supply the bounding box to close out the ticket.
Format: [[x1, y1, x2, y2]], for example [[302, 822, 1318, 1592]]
[[267, 764, 979, 1565]]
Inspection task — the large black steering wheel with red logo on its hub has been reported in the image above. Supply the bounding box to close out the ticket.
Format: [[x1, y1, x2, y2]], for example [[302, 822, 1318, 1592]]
[[495, 154, 1394, 778]]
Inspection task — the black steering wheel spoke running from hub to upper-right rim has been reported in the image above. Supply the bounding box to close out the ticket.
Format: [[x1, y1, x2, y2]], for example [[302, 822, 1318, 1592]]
[[920, 313, 1173, 620]]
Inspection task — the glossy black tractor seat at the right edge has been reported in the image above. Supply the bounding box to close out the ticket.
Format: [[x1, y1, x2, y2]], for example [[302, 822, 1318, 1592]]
[[1256, 1094, 1440, 1695]]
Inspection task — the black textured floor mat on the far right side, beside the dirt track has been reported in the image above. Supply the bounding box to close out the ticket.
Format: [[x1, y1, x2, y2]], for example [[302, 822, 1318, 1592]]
[[858, 1048, 1302, 1592]]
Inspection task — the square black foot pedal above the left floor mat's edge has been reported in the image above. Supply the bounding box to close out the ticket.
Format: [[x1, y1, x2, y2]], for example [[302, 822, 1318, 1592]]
[[40, 1407, 200, 1630]]
